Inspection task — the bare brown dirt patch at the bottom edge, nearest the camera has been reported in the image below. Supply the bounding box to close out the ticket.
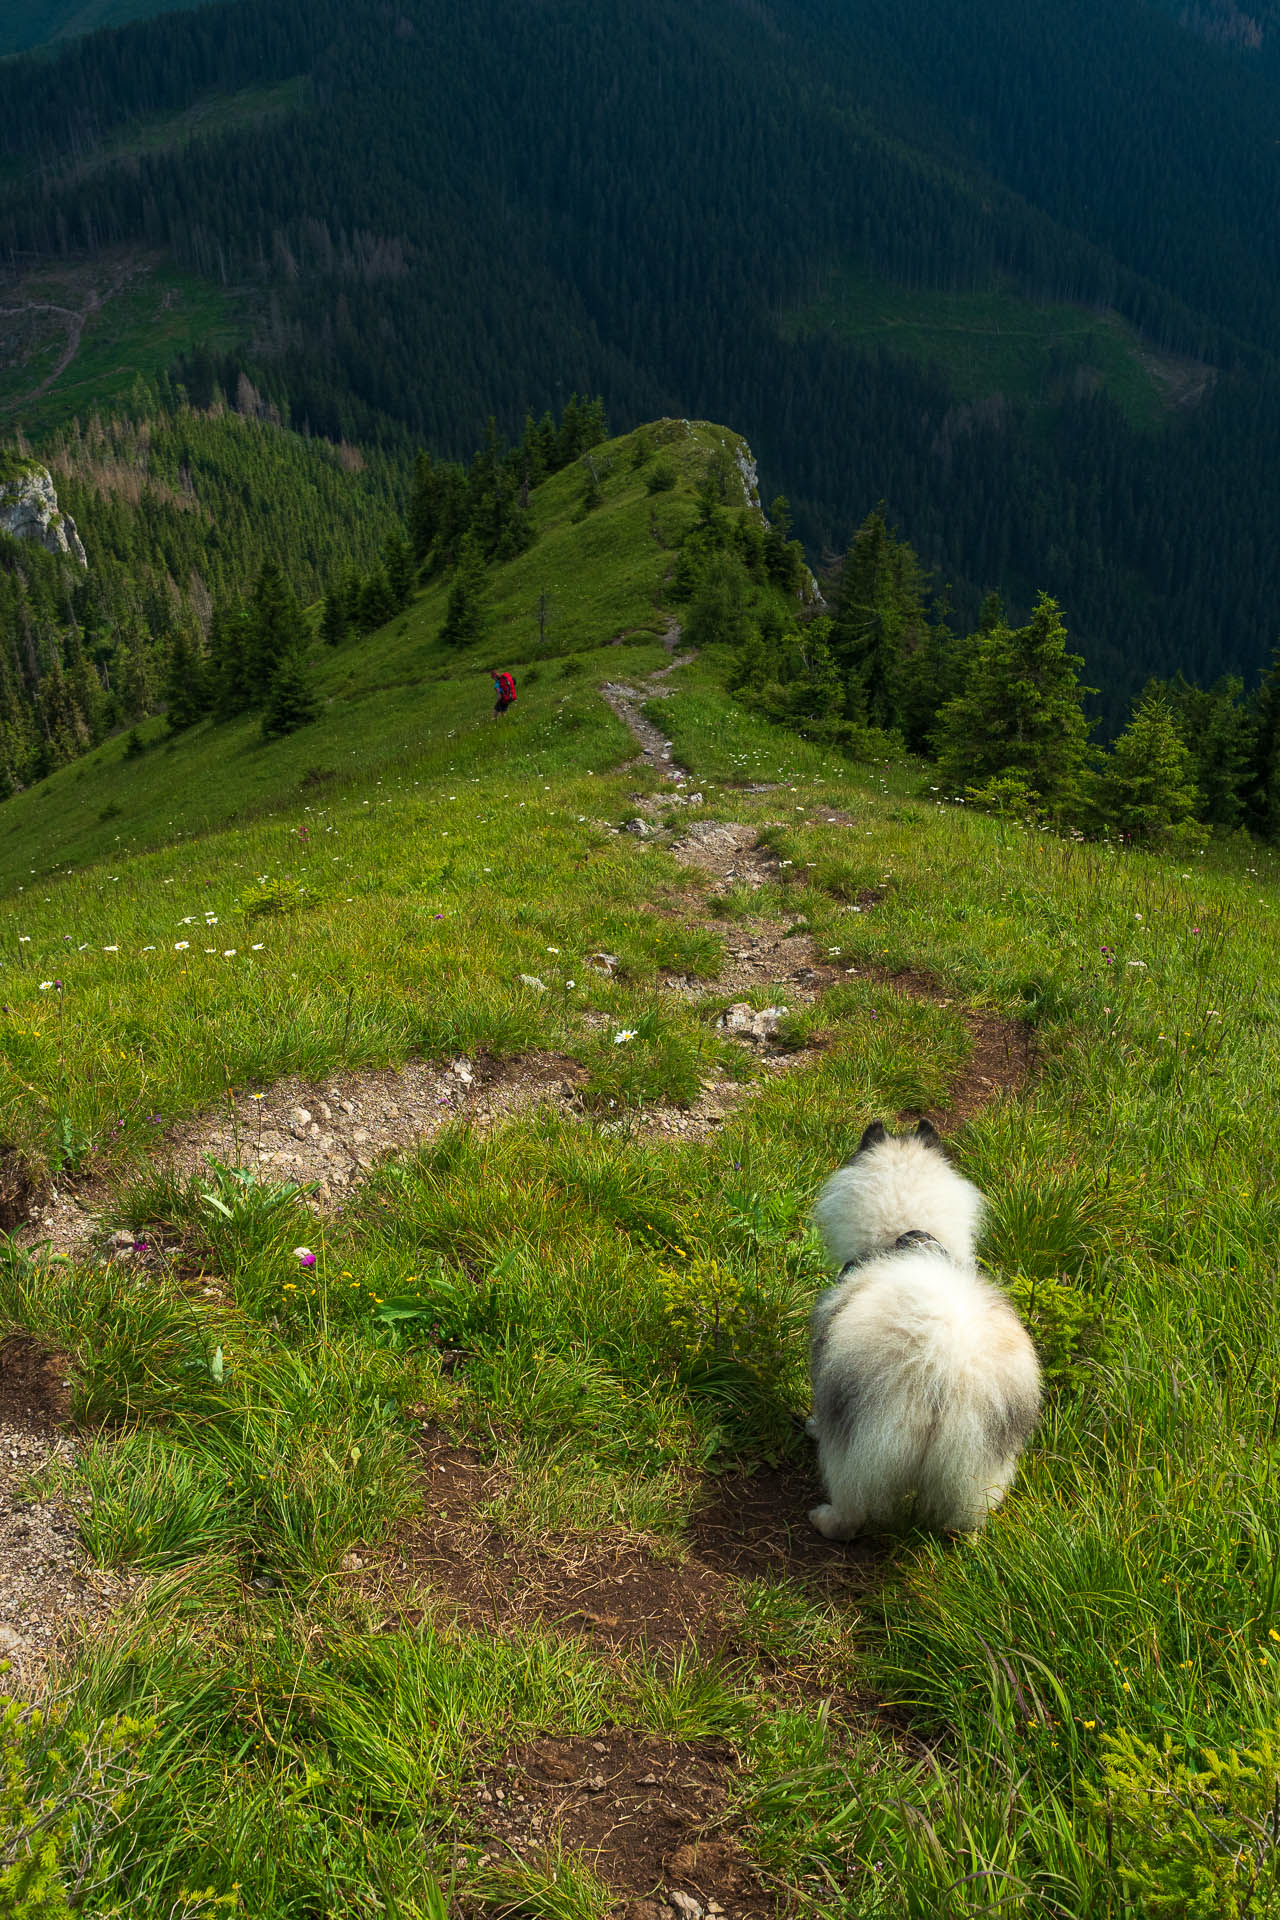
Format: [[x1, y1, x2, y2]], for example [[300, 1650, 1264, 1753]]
[[466, 1730, 783, 1920]]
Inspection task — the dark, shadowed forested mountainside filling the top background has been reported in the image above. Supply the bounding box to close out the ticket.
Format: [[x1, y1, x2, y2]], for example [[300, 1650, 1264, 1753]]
[[0, 0, 1280, 720]]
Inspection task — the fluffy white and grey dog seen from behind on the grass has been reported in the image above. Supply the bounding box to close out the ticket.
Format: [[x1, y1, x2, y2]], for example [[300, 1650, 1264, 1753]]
[[810, 1121, 1040, 1540]]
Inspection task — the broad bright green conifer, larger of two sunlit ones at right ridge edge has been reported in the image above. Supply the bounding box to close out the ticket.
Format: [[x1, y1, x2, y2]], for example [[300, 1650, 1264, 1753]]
[[938, 593, 1090, 820]]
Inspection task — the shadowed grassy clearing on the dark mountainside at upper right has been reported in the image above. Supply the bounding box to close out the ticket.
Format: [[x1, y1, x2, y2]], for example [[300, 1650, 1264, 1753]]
[[781, 269, 1205, 428]]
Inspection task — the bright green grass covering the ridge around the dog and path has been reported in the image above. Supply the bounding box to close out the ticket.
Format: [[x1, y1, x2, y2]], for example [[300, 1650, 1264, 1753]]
[[0, 416, 1280, 1920]]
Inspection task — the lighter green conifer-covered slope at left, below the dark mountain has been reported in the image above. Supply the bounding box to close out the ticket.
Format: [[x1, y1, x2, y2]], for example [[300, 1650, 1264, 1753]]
[[0, 397, 405, 799]]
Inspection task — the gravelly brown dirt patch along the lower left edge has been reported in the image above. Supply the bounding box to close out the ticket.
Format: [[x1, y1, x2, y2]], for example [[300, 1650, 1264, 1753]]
[[0, 1334, 142, 1697]]
